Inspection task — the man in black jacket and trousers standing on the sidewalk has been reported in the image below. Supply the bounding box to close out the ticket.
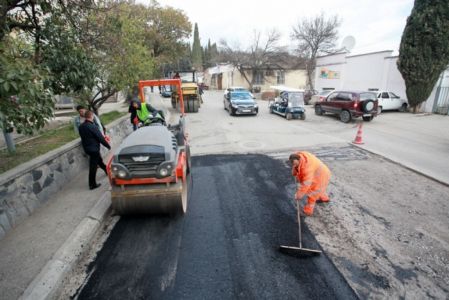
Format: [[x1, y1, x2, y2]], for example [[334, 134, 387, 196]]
[[79, 110, 111, 190]]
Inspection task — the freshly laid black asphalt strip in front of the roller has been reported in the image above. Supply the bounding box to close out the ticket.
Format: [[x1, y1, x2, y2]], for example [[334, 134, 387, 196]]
[[75, 155, 357, 300]]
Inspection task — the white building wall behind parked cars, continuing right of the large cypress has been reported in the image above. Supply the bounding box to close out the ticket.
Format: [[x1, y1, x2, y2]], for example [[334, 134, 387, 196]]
[[315, 50, 449, 114]]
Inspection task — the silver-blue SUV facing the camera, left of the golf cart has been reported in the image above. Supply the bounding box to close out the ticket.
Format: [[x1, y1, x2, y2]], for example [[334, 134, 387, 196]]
[[223, 91, 259, 116]]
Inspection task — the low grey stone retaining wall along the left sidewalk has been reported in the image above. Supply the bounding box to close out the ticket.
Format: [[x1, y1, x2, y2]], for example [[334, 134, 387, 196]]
[[0, 116, 132, 239]]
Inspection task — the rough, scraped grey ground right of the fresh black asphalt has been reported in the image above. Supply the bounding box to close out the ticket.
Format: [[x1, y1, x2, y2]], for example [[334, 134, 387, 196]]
[[298, 147, 449, 299]]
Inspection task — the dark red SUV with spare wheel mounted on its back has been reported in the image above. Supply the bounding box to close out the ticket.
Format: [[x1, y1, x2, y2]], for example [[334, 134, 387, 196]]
[[315, 91, 378, 123]]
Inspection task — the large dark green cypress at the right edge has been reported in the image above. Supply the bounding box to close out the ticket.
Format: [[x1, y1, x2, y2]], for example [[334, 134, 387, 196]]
[[398, 0, 449, 112]]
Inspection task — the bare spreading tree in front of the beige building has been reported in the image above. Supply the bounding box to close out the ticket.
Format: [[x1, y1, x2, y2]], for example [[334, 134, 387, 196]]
[[220, 29, 285, 89]]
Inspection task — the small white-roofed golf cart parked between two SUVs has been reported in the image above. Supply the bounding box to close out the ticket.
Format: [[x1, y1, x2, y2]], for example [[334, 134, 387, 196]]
[[268, 86, 306, 120]]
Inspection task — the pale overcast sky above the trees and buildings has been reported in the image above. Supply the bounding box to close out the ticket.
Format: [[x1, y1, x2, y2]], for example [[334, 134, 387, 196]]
[[138, 0, 414, 54]]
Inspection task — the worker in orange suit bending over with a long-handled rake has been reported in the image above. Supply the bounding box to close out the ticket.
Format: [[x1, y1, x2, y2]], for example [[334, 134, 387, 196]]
[[289, 151, 331, 216]]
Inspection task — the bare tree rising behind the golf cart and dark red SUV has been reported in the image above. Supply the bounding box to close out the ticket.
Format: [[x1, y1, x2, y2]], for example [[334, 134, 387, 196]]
[[291, 13, 341, 89]]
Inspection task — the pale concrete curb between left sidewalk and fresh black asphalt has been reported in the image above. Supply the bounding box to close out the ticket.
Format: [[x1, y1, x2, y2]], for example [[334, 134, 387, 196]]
[[20, 191, 111, 300]]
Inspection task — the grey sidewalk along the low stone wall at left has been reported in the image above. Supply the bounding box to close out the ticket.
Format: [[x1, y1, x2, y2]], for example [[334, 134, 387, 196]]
[[0, 170, 109, 300]]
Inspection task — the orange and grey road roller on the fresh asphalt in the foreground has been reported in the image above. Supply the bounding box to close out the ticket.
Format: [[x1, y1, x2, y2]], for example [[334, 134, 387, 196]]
[[107, 79, 190, 215]]
